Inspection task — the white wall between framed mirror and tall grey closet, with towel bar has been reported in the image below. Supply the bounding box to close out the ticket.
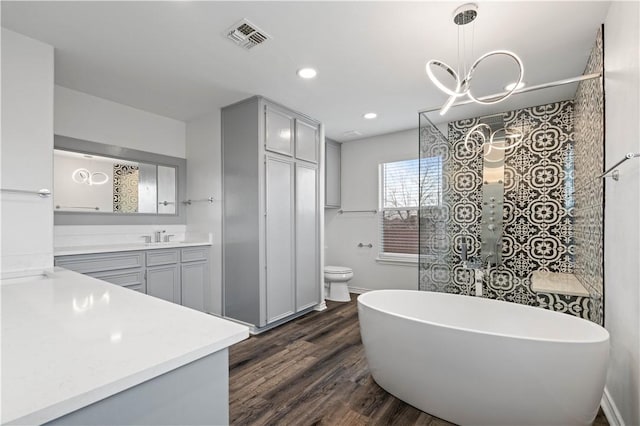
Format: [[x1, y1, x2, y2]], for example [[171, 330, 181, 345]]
[[186, 110, 222, 314]]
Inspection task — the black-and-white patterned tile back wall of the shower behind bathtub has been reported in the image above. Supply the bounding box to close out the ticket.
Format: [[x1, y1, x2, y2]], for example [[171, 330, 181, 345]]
[[419, 101, 575, 306]]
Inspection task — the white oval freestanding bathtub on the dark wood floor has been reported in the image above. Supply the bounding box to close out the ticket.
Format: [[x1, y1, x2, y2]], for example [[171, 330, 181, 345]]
[[358, 290, 609, 426]]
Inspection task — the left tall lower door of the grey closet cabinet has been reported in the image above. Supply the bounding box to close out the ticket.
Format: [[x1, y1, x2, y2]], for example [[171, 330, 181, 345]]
[[265, 155, 295, 323]]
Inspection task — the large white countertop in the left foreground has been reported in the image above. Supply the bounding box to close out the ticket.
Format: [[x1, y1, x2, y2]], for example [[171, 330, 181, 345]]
[[0, 268, 249, 424]]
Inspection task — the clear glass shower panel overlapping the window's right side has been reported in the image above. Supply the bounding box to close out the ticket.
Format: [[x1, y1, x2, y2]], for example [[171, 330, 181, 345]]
[[418, 114, 482, 294]]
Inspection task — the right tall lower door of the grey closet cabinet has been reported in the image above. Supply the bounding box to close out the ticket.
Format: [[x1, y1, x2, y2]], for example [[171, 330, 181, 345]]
[[296, 163, 320, 311]]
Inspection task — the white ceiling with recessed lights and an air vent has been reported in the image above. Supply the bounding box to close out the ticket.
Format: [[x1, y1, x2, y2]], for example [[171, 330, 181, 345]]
[[1, 1, 609, 141]]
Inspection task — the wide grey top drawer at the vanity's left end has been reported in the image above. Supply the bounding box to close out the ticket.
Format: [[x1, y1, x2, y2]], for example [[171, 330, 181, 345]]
[[55, 251, 144, 274]]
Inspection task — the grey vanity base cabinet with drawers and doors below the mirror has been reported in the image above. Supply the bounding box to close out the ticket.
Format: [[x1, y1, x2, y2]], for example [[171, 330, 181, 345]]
[[55, 246, 209, 312]]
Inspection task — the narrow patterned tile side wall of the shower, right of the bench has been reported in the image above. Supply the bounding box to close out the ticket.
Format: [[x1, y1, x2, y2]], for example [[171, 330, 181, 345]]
[[574, 28, 604, 324]]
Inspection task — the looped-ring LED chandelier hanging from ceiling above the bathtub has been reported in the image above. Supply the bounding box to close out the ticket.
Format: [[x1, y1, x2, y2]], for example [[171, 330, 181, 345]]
[[426, 3, 524, 115]]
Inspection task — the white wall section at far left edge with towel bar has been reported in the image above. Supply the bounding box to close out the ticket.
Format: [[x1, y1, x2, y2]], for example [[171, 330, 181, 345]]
[[0, 28, 53, 274]]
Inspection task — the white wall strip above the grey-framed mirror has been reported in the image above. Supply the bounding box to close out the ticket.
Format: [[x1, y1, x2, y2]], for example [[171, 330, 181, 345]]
[[54, 86, 186, 158]]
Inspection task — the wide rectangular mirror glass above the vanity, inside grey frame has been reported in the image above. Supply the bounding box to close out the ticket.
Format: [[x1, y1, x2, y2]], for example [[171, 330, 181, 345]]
[[53, 149, 177, 215]]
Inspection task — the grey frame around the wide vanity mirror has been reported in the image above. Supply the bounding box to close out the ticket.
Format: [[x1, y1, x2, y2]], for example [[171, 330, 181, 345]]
[[51, 135, 187, 225]]
